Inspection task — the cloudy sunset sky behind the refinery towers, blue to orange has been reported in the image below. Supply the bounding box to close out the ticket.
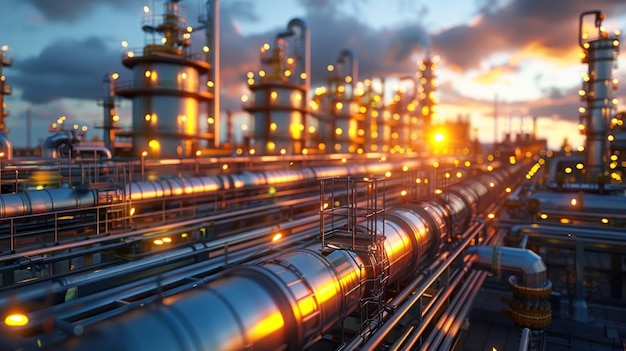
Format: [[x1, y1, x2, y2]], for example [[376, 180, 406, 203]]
[[0, 0, 626, 147]]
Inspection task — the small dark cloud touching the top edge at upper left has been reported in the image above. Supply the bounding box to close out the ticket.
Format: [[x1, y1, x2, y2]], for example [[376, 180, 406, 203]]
[[22, 0, 135, 22]]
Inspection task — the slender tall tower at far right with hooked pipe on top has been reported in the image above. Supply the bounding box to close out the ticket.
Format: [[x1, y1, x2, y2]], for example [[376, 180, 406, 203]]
[[579, 10, 619, 183]]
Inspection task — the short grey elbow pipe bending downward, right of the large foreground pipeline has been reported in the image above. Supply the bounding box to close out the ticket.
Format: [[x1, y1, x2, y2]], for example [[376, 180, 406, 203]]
[[467, 245, 546, 288]]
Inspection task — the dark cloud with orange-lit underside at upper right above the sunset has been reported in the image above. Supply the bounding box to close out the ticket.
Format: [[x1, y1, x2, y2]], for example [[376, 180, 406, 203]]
[[431, 0, 626, 70]]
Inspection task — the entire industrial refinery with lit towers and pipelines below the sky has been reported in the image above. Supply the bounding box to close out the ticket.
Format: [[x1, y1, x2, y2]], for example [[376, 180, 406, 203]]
[[0, 0, 626, 351]]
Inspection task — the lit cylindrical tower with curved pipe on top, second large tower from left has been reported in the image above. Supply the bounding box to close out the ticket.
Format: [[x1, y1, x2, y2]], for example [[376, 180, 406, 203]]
[[243, 18, 310, 155]]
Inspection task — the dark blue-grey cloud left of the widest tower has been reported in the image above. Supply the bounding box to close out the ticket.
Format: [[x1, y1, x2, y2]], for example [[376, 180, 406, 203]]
[[12, 37, 122, 104]]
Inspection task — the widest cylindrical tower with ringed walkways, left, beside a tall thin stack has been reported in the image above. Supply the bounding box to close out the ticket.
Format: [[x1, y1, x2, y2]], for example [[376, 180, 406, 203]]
[[115, 0, 214, 157]]
